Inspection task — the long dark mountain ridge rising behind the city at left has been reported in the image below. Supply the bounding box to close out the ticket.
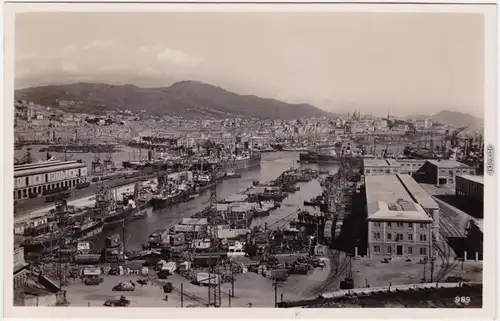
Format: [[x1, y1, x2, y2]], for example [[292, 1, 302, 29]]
[[15, 81, 330, 119]]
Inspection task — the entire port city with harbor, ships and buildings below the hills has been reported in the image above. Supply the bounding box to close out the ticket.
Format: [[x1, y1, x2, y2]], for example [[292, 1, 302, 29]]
[[13, 100, 484, 308]]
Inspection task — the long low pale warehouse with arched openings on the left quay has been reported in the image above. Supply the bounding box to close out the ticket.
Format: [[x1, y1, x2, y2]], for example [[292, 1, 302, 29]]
[[14, 161, 87, 199]]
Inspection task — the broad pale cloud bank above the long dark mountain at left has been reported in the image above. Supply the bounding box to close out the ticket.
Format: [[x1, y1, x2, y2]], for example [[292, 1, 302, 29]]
[[16, 40, 203, 83]]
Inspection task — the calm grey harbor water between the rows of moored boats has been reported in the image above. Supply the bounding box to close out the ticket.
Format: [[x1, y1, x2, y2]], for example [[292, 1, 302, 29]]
[[92, 152, 338, 251]]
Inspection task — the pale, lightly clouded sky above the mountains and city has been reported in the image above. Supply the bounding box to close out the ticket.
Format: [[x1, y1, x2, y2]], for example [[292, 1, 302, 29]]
[[15, 12, 484, 117]]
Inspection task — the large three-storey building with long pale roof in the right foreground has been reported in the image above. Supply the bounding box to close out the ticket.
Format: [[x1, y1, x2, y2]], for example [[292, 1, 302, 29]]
[[365, 175, 433, 260]]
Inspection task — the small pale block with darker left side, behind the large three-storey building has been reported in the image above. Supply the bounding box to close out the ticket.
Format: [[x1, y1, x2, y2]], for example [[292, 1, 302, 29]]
[[419, 159, 476, 185]]
